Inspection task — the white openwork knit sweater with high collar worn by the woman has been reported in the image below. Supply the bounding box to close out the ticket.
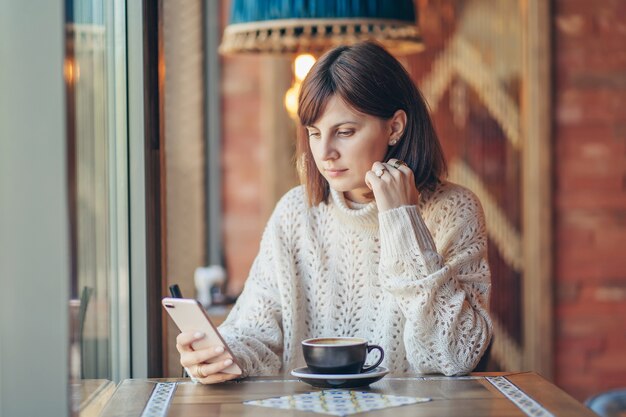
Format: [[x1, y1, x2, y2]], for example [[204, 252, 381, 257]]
[[220, 182, 492, 376]]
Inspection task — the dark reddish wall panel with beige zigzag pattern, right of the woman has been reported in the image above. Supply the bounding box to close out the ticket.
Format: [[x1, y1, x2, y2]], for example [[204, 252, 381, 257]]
[[406, 0, 524, 370]]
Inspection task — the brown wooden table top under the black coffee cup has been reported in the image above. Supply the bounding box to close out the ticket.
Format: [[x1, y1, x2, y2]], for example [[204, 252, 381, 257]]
[[101, 372, 597, 417]]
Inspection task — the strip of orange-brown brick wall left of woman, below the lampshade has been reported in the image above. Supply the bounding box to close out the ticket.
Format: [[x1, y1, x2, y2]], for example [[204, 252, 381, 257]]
[[222, 56, 267, 294]]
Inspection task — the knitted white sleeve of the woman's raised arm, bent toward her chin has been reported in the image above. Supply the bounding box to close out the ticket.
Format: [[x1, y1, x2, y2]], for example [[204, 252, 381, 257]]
[[379, 187, 492, 375]]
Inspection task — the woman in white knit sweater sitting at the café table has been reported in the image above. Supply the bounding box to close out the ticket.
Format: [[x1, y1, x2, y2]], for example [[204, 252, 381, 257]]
[[177, 42, 492, 383]]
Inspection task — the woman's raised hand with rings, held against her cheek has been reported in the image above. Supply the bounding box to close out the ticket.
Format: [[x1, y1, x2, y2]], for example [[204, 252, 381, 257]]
[[365, 159, 419, 212]]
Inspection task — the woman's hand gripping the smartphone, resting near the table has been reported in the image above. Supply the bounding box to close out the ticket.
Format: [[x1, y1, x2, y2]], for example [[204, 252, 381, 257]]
[[176, 332, 239, 384]]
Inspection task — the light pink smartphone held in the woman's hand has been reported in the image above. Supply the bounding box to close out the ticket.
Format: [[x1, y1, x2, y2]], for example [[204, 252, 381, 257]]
[[161, 298, 242, 375]]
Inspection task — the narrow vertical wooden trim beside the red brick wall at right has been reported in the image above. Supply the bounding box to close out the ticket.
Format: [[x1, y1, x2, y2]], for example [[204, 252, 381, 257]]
[[522, 0, 554, 380]]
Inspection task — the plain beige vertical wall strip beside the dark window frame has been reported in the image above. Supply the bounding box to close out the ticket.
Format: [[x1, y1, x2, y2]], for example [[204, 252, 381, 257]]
[[163, 0, 205, 376]]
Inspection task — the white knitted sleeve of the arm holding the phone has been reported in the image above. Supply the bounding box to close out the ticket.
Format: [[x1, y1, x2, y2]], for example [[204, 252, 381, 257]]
[[219, 207, 283, 377]]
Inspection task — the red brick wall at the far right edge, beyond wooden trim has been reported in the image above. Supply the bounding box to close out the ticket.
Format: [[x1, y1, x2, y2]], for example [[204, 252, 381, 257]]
[[553, 0, 626, 400]]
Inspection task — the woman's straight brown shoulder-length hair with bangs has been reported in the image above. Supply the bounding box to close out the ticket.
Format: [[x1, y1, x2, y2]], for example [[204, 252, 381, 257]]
[[296, 41, 446, 205]]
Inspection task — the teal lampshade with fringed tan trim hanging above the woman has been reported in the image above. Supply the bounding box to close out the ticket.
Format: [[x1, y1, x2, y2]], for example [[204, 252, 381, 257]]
[[220, 0, 424, 54]]
